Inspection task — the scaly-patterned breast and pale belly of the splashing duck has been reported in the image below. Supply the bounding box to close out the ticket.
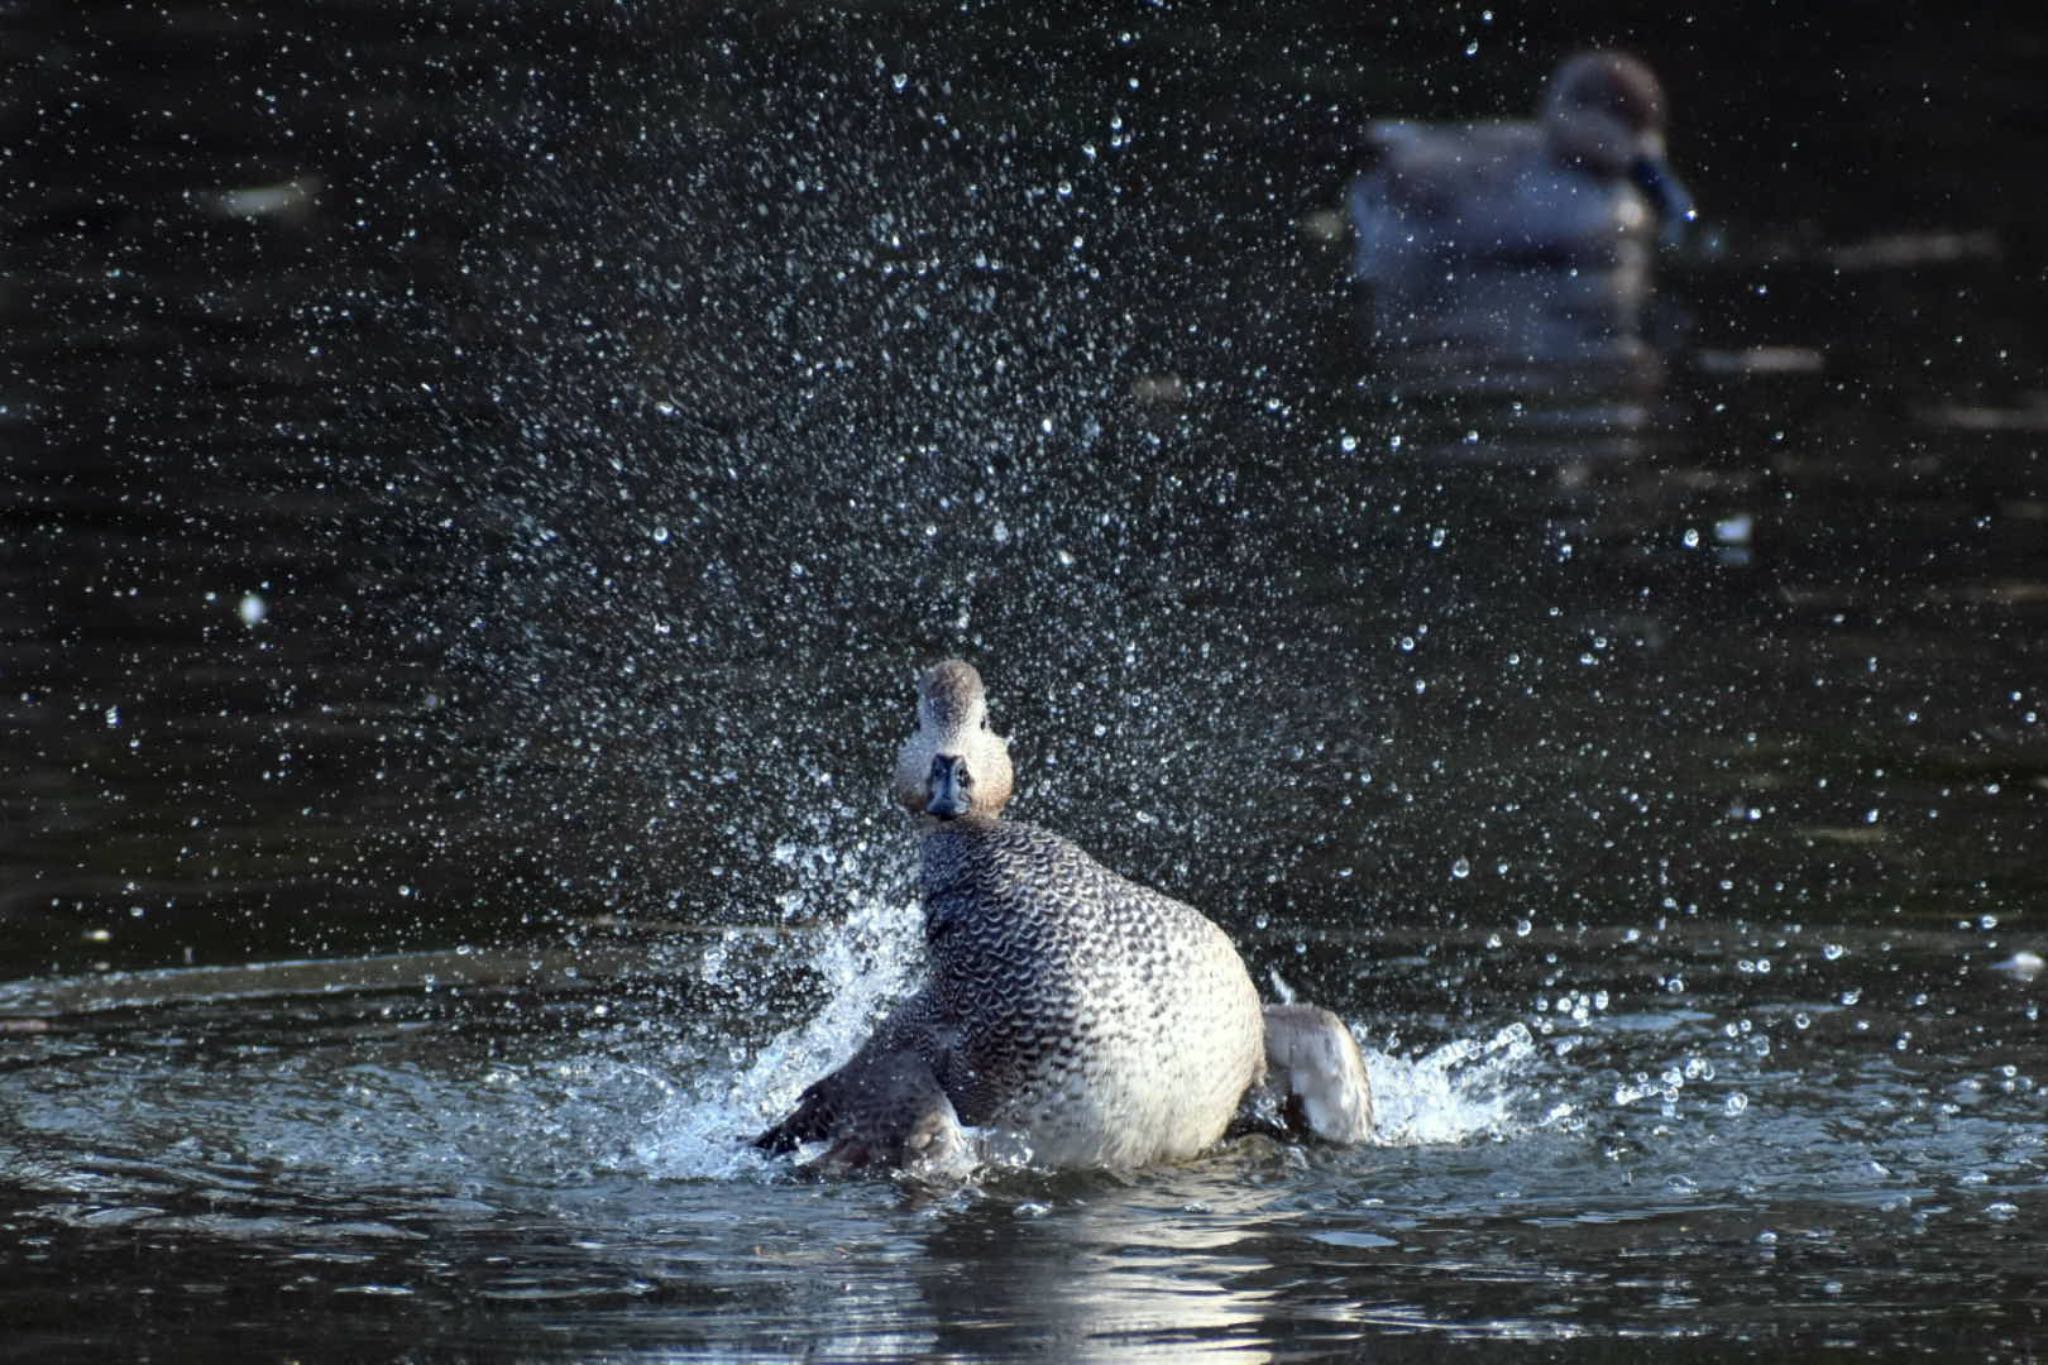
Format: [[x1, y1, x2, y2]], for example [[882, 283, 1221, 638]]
[[922, 821, 1266, 1166]]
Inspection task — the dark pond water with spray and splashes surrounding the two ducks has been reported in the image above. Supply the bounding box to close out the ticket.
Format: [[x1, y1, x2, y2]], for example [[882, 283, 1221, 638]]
[[0, 4, 2048, 1359]]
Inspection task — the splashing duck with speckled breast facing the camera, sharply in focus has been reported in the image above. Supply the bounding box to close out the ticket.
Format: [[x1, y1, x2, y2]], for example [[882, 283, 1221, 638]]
[[754, 659, 1372, 1175]]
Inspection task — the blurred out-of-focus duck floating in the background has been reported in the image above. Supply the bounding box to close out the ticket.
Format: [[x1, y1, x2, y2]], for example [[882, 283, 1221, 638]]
[[1348, 51, 1696, 282]]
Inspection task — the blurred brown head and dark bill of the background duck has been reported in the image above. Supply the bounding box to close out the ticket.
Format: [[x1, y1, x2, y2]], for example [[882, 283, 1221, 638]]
[[1538, 51, 1694, 235]]
